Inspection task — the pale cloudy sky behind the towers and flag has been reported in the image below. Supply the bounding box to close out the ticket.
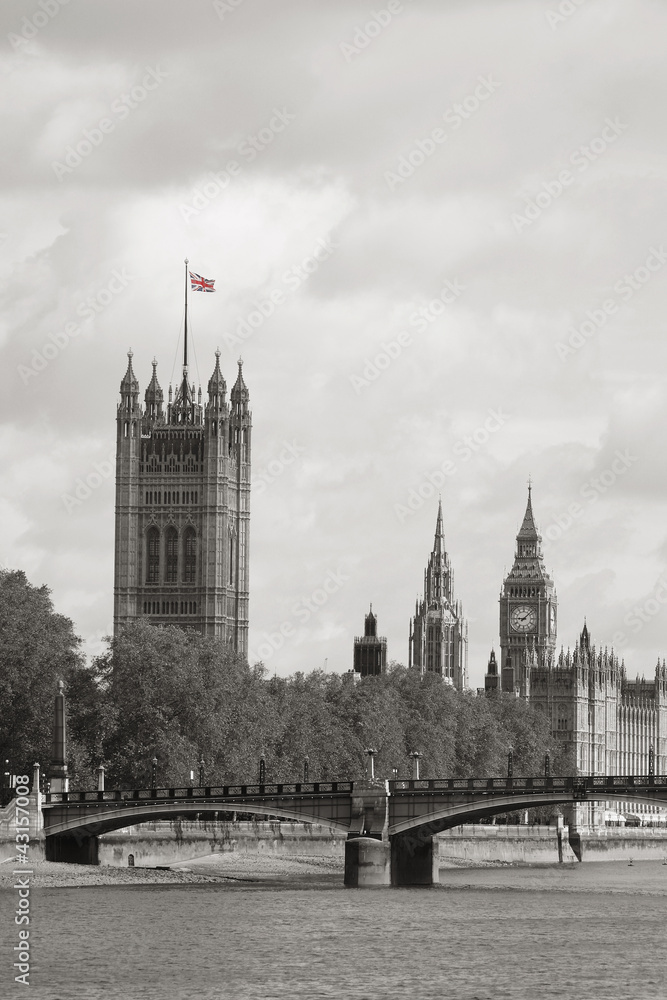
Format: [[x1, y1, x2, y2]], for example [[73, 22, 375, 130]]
[[0, 0, 667, 687]]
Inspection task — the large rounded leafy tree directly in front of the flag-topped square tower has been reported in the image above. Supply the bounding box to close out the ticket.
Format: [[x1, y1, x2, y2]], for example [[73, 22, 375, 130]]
[[93, 619, 270, 787]]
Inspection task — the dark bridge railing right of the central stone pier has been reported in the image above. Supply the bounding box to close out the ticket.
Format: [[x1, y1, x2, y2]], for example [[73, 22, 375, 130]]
[[389, 774, 667, 795]]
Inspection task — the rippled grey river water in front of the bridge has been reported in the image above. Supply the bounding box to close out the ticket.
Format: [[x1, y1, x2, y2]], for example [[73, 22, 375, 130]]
[[9, 861, 667, 1000]]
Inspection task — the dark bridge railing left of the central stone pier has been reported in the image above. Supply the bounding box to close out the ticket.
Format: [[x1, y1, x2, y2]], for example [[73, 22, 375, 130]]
[[45, 781, 352, 805]]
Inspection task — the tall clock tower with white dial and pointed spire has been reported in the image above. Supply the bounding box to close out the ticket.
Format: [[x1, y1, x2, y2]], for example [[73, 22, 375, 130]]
[[500, 485, 558, 698]]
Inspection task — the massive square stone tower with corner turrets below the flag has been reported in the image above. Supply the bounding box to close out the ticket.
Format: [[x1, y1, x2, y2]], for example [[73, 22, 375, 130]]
[[114, 351, 252, 655]]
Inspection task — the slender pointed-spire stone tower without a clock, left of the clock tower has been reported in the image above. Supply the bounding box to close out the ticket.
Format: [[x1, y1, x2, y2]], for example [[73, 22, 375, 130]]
[[409, 502, 468, 691]]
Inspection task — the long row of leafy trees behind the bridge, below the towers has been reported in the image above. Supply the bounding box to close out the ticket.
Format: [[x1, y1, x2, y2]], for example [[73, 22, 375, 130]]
[[0, 570, 571, 789]]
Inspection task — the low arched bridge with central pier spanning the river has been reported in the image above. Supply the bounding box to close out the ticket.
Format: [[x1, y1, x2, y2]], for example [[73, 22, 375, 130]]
[[33, 775, 667, 886]]
